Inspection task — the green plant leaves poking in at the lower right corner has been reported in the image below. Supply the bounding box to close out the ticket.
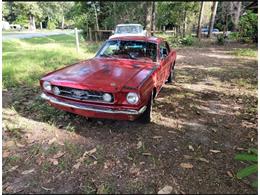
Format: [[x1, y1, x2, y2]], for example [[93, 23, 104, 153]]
[[235, 148, 258, 188]]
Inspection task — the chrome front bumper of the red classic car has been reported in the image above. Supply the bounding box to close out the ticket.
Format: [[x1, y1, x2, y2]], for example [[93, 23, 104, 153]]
[[41, 93, 146, 115]]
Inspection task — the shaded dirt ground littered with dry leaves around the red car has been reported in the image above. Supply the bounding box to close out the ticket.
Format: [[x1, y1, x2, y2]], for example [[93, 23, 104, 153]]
[[3, 41, 258, 194]]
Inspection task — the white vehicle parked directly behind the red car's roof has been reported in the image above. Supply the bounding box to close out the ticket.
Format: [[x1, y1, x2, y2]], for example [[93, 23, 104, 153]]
[[109, 24, 147, 38]]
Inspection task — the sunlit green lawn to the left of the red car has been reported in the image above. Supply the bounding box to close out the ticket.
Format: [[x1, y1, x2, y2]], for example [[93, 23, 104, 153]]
[[2, 35, 100, 88]]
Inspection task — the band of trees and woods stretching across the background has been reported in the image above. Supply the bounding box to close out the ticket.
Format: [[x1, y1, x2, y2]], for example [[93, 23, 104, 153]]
[[3, 1, 257, 41]]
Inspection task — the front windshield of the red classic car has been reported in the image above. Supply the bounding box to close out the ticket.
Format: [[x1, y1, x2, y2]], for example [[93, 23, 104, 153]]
[[98, 40, 157, 62]]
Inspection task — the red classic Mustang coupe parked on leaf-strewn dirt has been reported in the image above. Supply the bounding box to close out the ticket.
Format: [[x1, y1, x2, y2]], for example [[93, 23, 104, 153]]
[[40, 36, 176, 123]]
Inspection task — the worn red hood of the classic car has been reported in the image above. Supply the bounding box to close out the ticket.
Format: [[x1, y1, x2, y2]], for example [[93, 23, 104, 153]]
[[42, 58, 156, 92]]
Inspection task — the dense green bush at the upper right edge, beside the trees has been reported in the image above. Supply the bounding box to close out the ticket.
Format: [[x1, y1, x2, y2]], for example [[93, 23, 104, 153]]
[[239, 11, 258, 42]]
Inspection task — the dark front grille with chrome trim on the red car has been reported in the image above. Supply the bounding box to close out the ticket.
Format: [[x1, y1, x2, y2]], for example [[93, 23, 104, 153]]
[[53, 86, 114, 103]]
